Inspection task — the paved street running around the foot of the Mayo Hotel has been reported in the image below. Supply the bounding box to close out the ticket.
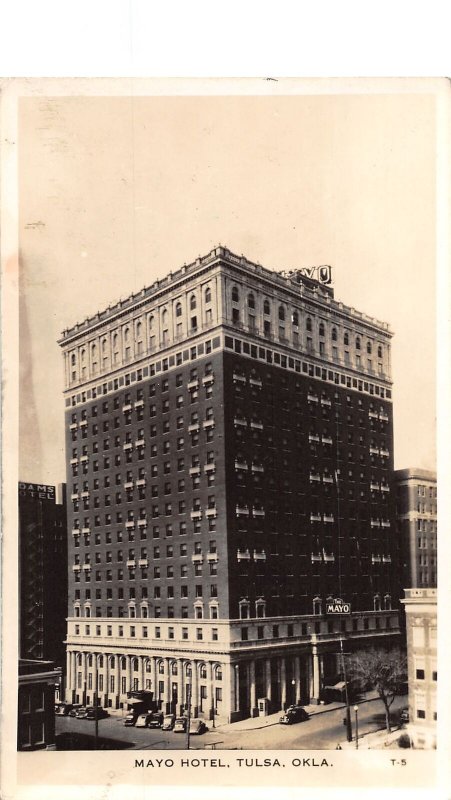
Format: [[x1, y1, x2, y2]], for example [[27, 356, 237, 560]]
[[55, 697, 406, 750]]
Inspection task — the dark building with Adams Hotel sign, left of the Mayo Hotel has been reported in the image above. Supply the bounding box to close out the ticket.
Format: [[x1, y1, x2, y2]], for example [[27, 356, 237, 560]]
[[19, 482, 68, 666]]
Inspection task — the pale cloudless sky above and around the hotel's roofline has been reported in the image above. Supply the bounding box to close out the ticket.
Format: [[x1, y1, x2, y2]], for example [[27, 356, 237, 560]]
[[18, 81, 436, 484]]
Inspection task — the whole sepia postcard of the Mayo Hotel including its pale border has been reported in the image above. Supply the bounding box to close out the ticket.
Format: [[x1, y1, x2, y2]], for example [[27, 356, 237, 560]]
[[2, 73, 448, 788]]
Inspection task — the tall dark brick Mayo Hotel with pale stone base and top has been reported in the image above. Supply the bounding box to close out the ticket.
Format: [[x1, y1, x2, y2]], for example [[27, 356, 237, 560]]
[[60, 247, 400, 721]]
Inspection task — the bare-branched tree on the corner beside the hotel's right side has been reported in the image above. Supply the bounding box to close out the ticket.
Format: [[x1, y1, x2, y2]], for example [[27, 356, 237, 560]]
[[347, 648, 407, 731]]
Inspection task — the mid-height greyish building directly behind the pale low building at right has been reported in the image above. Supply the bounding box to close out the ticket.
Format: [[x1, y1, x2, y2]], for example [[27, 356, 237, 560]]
[[395, 469, 437, 588]]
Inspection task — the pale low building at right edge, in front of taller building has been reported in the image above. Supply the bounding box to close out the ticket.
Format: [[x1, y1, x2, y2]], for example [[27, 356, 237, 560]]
[[401, 588, 437, 749]]
